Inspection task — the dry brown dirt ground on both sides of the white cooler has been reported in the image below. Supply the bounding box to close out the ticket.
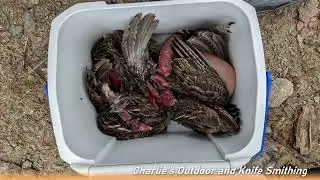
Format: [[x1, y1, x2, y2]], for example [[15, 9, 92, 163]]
[[0, 0, 320, 174]]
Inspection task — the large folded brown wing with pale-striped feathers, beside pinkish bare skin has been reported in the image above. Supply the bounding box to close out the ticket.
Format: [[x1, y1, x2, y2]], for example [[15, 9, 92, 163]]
[[172, 38, 230, 104]]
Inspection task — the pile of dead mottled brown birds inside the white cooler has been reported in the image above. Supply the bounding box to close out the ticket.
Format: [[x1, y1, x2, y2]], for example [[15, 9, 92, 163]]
[[86, 13, 240, 140]]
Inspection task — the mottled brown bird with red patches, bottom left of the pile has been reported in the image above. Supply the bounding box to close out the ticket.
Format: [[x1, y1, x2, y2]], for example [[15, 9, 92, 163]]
[[97, 81, 168, 140]]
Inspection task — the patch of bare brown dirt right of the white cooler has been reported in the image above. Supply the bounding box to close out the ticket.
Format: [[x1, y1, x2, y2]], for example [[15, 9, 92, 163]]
[[255, 0, 320, 167]]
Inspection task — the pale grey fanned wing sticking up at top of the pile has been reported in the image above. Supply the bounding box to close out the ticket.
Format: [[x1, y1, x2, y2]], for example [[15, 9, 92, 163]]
[[122, 13, 159, 80]]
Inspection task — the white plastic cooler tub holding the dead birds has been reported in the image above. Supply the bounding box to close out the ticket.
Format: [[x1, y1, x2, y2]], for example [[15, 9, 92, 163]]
[[48, 0, 266, 174]]
